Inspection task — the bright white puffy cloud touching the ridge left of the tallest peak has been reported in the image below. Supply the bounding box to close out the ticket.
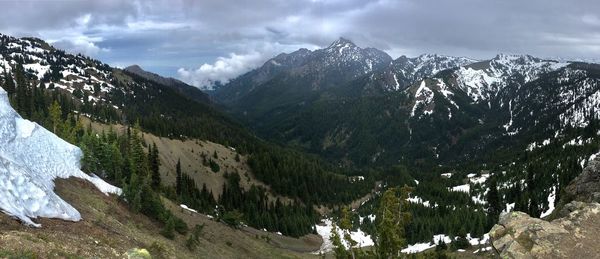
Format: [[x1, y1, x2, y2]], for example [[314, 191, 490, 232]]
[[177, 51, 266, 89]]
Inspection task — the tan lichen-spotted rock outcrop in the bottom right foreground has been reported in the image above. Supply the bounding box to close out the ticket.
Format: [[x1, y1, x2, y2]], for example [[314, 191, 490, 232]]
[[490, 158, 600, 258]]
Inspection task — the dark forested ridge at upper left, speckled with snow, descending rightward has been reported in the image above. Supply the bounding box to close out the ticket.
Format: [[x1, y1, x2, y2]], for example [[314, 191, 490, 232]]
[[0, 35, 253, 149]]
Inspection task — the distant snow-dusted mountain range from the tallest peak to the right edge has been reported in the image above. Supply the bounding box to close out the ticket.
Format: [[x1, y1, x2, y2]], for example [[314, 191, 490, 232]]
[[211, 38, 597, 170]]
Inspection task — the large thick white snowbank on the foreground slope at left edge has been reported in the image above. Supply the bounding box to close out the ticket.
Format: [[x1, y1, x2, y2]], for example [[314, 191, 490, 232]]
[[0, 88, 121, 227]]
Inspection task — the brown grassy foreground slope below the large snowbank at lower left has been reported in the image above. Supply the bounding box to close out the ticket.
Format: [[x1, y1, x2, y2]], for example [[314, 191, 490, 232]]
[[0, 179, 320, 258]]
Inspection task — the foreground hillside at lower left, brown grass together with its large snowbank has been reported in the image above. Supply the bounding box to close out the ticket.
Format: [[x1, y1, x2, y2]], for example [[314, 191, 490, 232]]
[[0, 61, 320, 258]]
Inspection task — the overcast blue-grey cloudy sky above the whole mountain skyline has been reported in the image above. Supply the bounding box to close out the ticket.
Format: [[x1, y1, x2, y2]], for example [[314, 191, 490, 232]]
[[0, 0, 600, 86]]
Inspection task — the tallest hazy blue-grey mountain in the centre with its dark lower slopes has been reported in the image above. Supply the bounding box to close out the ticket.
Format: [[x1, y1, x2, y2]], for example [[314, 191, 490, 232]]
[[213, 39, 482, 165]]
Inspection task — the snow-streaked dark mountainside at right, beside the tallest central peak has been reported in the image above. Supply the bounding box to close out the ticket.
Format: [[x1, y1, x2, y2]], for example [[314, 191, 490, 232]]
[[409, 59, 598, 162]]
